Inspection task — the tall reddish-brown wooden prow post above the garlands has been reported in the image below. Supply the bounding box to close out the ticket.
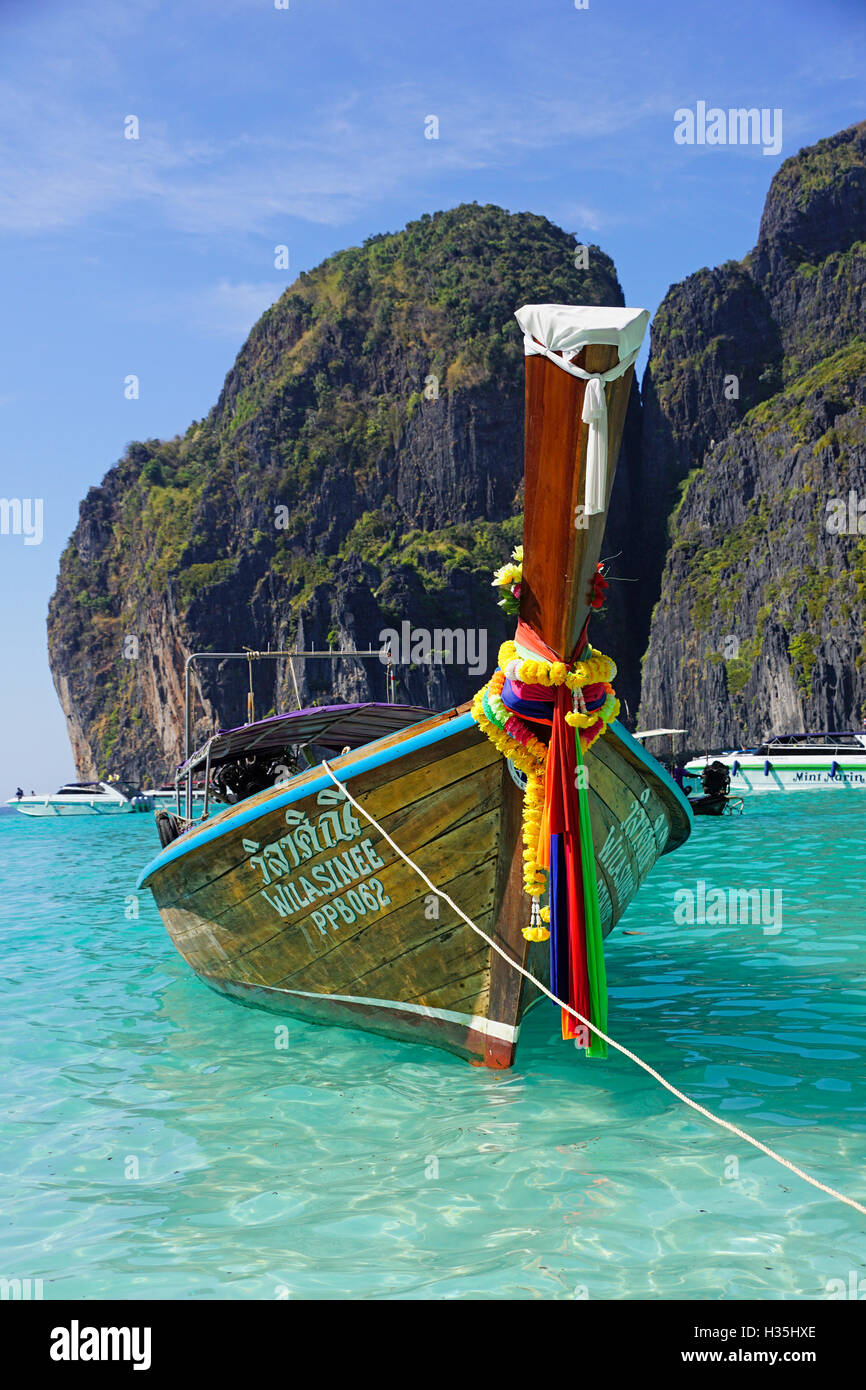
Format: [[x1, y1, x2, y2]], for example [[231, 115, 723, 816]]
[[520, 343, 634, 662]]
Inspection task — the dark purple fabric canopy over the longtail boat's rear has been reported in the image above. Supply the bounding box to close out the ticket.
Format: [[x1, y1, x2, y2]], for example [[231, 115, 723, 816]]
[[178, 701, 431, 777]]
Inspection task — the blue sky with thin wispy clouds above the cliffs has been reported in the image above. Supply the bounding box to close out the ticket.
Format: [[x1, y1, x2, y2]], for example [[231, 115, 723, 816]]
[[0, 0, 866, 798]]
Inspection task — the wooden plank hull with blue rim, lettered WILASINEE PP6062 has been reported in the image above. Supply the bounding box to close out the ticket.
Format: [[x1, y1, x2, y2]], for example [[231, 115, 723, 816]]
[[140, 710, 691, 1068]]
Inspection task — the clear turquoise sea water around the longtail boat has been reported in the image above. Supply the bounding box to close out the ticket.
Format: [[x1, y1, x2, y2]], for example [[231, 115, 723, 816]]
[[0, 792, 866, 1300]]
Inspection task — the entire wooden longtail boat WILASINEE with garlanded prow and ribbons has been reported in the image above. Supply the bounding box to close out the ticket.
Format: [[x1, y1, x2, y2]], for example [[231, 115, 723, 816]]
[[139, 304, 691, 1068]]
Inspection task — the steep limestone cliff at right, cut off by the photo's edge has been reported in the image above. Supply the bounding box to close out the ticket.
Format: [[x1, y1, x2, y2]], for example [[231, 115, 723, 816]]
[[641, 124, 866, 746]]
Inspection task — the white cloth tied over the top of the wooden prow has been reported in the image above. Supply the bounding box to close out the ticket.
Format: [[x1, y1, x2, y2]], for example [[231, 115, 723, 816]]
[[514, 304, 649, 516]]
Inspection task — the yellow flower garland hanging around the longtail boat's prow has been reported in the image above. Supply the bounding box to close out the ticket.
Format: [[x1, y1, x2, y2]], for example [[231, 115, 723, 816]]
[[471, 636, 620, 941]]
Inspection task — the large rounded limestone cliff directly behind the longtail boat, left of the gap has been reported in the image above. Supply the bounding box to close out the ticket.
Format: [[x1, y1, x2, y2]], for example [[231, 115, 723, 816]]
[[49, 204, 639, 777]]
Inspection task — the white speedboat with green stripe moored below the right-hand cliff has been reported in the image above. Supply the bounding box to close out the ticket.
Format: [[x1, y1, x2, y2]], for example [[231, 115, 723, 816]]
[[684, 731, 866, 794]]
